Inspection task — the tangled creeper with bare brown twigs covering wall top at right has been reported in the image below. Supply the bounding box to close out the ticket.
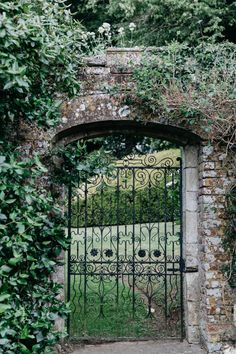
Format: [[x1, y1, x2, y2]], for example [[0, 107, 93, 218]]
[[134, 43, 236, 143]]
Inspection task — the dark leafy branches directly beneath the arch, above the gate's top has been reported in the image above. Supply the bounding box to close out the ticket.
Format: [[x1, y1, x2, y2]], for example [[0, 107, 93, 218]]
[[54, 134, 175, 184]]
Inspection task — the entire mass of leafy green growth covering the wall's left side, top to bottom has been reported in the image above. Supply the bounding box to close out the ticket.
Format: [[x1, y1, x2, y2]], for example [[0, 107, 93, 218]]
[[0, 0, 86, 354]]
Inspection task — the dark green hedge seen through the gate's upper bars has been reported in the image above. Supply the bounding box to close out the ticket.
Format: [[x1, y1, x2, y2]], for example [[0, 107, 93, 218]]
[[72, 181, 179, 227]]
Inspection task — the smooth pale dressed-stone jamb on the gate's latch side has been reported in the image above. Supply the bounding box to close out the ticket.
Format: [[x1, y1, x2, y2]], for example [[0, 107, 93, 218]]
[[183, 145, 200, 343]]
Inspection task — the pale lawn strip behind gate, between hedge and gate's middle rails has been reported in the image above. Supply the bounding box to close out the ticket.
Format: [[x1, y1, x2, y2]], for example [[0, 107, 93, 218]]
[[71, 222, 180, 261]]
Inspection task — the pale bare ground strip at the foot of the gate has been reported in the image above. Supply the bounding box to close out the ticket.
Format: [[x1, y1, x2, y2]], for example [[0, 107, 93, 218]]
[[69, 340, 206, 354]]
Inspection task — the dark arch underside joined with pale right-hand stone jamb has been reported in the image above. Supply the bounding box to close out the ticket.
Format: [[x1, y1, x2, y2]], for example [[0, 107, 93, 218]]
[[53, 117, 202, 343]]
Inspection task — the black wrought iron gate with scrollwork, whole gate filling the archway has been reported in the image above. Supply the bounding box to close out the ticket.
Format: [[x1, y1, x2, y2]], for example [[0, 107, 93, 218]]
[[67, 155, 184, 338]]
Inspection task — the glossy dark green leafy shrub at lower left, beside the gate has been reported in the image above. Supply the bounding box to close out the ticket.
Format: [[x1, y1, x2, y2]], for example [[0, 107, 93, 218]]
[[0, 153, 67, 354]]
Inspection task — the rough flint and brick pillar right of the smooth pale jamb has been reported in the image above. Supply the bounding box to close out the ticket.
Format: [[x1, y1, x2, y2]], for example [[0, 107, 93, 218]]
[[199, 145, 235, 353]]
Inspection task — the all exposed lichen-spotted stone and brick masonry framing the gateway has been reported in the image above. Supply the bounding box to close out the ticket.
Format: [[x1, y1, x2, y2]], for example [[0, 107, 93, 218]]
[[18, 48, 236, 354]]
